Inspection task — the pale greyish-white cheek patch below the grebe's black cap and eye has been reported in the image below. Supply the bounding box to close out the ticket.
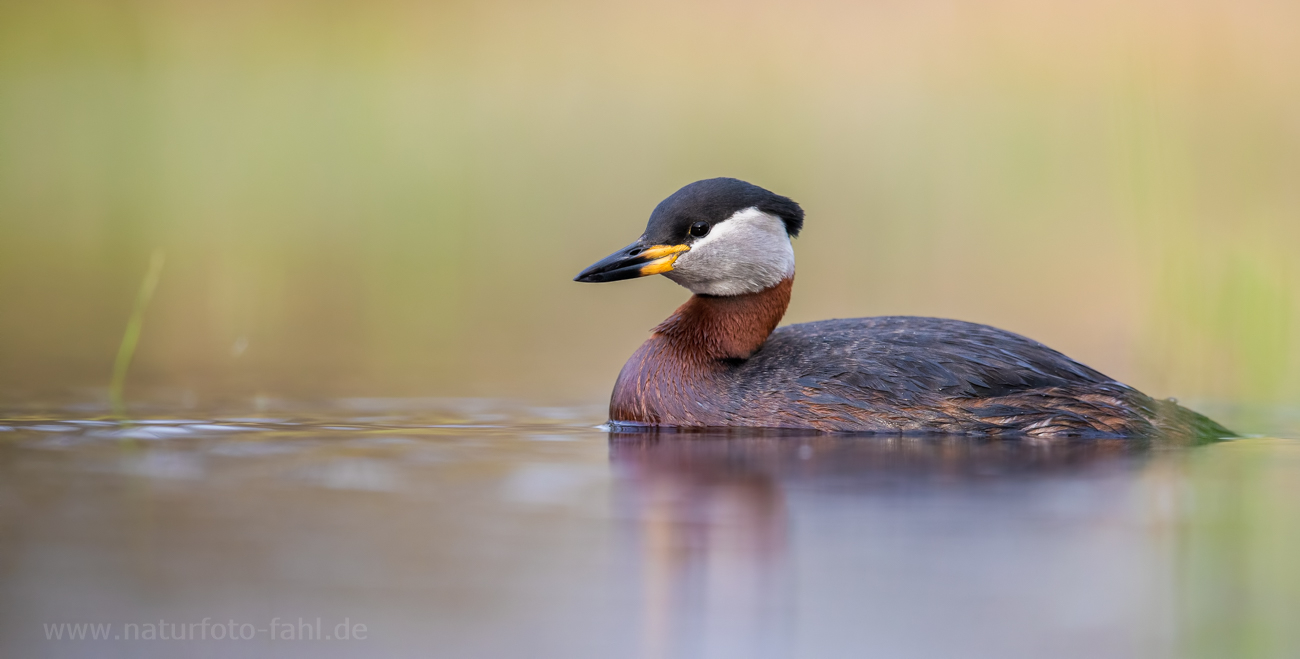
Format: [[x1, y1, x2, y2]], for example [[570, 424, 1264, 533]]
[[664, 208, 794, 295]]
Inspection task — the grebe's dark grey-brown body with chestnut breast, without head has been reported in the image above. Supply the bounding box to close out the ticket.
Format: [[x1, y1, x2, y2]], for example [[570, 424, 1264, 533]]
[[610, 278, 1226, 437]]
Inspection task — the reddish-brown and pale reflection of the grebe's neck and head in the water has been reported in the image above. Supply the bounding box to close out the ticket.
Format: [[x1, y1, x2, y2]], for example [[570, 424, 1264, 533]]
[[610, 430, 798, 659]]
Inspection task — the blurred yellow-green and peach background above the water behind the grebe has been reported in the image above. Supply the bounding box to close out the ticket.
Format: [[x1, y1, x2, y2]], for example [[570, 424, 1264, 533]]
[[0, 0, 1300, 415]]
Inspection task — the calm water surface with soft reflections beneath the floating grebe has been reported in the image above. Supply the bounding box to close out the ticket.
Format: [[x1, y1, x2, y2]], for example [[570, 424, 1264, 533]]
[[0, 400, 1300, 658]]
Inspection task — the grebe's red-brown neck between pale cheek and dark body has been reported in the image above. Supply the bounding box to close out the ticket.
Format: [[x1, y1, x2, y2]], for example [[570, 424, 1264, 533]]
[[654, 274, 794, 359]]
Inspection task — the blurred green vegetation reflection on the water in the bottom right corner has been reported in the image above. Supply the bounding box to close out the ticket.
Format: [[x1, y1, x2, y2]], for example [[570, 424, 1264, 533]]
[[1180, 439, 1300, 658]]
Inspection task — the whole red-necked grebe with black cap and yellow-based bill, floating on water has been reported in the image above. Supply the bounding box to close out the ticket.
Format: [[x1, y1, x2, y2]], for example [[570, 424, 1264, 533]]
[[576, 178, 1231, 437]]
